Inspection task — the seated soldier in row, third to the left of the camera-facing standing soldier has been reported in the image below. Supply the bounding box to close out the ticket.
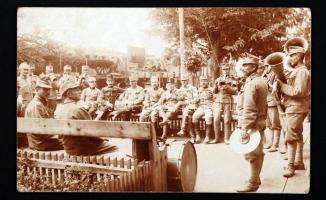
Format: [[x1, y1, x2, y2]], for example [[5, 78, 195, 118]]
[[158, 78, 179, 139]]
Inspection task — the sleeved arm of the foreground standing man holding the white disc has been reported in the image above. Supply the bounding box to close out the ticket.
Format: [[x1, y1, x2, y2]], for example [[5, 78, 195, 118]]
[[241, 84, 258, 131]]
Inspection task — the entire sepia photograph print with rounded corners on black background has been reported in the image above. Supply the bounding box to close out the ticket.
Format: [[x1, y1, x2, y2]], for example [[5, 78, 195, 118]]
[[16, 7, 311, 194]]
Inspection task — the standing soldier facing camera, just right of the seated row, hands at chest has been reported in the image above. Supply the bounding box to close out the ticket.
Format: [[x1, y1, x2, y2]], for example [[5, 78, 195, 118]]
[[211, 63, 237, 145]]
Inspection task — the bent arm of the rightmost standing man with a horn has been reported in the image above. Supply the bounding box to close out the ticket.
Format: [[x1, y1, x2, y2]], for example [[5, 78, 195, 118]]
[[279, 70, 310, 97]]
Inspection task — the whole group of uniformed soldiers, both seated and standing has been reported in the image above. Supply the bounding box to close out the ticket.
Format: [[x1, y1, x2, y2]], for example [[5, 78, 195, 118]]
[[17, 36, 310, 192]]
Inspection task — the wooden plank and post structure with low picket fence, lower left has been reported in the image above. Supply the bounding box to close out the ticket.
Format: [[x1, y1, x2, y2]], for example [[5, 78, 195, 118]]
[[17, 118, 167, 192]]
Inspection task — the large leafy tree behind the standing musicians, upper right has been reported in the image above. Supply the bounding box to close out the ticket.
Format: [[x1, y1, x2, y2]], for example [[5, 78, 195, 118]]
[[151, 8, 310, 79]]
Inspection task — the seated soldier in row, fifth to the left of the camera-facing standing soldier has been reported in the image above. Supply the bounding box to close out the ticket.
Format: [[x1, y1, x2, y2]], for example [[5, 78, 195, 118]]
[[112, 76, 144, 120]]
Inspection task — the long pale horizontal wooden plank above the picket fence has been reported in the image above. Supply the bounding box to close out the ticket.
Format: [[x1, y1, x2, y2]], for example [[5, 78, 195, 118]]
[[17, 118, 151, 139]]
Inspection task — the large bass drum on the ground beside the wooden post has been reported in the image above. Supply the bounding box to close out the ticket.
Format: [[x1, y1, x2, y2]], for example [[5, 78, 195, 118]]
[[167, 140, 197, 192]]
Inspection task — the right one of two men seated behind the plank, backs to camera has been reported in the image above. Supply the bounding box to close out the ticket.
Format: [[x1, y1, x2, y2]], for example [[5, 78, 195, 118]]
[[55, 81, 117, 156]]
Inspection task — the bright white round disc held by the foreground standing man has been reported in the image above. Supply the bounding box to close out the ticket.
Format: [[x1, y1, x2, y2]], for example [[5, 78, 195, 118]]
[[230, 128, 261, 154]]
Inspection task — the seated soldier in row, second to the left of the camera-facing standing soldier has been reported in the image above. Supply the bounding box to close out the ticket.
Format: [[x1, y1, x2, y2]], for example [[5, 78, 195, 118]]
[[177, 74, 200, 138]]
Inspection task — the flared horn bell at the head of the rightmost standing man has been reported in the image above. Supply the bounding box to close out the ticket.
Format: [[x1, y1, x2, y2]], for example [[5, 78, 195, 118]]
[[284, 37, 309, 55]]
